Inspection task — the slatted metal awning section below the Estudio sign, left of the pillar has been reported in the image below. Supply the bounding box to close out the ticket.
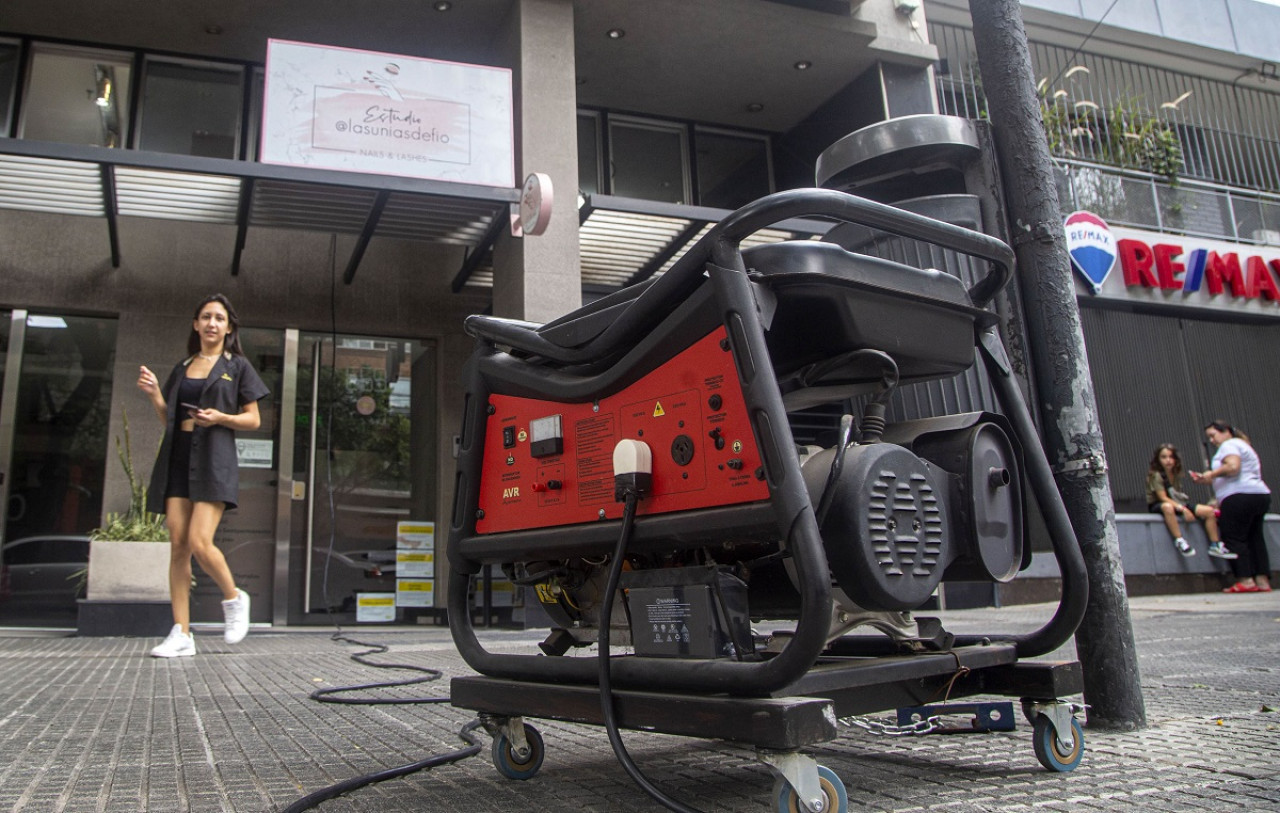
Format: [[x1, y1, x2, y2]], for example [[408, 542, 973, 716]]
[[0, 140, 520, 283]]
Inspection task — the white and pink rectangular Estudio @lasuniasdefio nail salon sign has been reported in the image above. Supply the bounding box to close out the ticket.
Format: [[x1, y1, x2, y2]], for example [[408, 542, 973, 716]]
[[261, 40, 515, 187]]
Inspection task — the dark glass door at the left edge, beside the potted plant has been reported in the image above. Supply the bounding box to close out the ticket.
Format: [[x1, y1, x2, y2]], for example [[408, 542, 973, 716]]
[[0, 310, 116, 627]]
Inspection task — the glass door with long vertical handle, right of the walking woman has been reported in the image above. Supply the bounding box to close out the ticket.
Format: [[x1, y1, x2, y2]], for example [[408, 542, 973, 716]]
[[289, 333, 436, 624]]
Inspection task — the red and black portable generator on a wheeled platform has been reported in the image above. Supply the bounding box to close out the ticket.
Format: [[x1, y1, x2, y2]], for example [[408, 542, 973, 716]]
[[448, 189, 1087, 813]]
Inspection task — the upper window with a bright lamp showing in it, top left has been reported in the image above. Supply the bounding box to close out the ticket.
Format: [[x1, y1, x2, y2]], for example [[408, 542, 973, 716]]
[[19, 45, 133, 147]]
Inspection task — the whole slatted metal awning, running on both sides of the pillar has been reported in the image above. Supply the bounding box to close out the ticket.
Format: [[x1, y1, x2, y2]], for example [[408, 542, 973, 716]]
[[0, 138, 831, 293]]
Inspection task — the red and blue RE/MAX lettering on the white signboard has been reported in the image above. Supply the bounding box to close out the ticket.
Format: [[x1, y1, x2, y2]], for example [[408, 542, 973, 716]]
[[1116, 238, 1280, 302]]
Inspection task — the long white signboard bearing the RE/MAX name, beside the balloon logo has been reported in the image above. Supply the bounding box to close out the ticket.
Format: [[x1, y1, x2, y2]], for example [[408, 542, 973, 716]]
[[1069, 212, 1280, 318]]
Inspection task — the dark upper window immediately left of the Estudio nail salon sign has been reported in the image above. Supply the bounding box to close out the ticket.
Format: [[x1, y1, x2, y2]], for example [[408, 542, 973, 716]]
[[138, 59, 243, 159]]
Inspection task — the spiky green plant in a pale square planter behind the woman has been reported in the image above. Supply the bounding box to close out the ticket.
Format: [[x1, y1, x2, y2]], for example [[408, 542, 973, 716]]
[[79, 415, 169, 635]]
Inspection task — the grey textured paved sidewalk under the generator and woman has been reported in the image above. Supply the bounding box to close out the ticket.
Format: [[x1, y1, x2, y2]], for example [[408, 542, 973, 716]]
[[0, 592, 1280, 813]]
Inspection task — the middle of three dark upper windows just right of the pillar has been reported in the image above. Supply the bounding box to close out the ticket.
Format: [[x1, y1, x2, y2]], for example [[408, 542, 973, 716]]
[[609, 118, 690, 204]]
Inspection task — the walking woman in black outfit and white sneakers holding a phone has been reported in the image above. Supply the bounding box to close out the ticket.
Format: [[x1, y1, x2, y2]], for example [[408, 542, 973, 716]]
[[138, 293, 268, 658]]
